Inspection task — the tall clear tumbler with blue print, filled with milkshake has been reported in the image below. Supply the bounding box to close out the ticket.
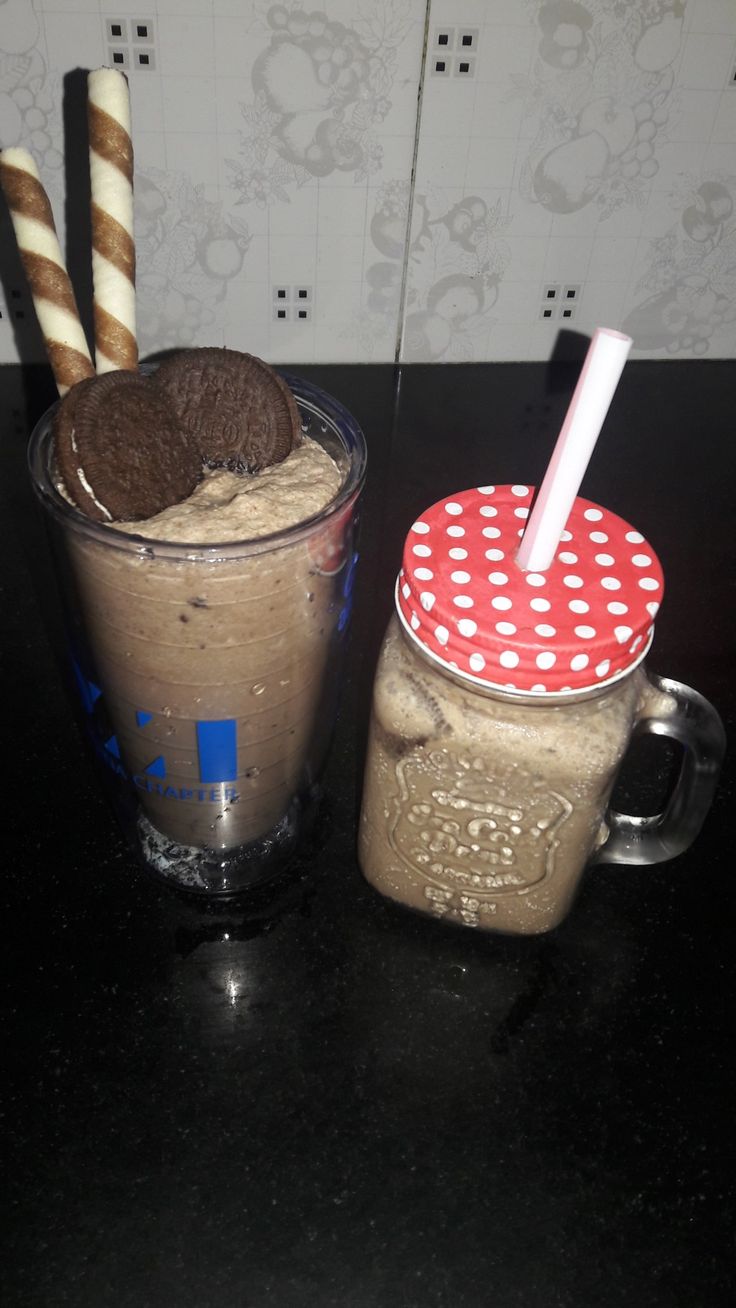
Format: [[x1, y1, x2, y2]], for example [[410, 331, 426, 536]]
[[29, 378, 366, 895]]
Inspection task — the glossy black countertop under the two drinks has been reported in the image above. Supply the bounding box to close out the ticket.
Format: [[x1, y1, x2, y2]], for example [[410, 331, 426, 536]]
[[0, 362, 736, 1308]]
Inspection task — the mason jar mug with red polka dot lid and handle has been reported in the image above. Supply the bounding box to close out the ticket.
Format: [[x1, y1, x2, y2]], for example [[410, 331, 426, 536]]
[[360, 485, 726, 934]]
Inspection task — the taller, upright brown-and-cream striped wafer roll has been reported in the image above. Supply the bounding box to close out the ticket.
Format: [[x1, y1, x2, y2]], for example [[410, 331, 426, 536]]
[[88, 68, 139, 373]]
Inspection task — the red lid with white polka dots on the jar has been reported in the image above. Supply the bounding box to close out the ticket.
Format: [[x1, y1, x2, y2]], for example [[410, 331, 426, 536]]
[[396, 485, 664, 695]]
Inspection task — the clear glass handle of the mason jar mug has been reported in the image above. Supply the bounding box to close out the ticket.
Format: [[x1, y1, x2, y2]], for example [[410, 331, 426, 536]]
[[591, 674, 726, 865]]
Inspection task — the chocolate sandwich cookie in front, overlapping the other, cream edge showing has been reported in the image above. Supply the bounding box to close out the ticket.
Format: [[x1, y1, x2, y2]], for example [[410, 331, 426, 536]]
[[54, 371, 201, 522]]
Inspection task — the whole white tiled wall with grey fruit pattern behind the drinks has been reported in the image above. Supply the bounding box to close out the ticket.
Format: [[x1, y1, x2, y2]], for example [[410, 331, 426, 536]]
[[0, 0, 736, 362]]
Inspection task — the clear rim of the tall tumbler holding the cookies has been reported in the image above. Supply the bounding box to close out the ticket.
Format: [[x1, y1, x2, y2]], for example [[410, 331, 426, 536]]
[[27, 369, 367, 562]]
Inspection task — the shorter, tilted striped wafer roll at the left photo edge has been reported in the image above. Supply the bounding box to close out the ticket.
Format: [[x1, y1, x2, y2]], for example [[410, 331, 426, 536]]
[[0, 146, 94, 395]]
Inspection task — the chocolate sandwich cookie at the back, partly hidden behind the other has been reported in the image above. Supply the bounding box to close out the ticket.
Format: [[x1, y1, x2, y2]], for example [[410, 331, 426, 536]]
[[154, 348, 302, 472]]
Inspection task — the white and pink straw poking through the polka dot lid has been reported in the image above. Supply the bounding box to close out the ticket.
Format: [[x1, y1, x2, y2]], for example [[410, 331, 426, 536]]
[[516, 327, 631, 572]]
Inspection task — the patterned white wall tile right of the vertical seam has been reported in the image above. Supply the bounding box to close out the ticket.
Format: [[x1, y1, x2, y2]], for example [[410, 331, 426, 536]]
[[401, 0, 736, 362]]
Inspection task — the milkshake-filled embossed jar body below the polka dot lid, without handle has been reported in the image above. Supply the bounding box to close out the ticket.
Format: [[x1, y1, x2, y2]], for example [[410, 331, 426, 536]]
[[360, 617, 646, 933]]
